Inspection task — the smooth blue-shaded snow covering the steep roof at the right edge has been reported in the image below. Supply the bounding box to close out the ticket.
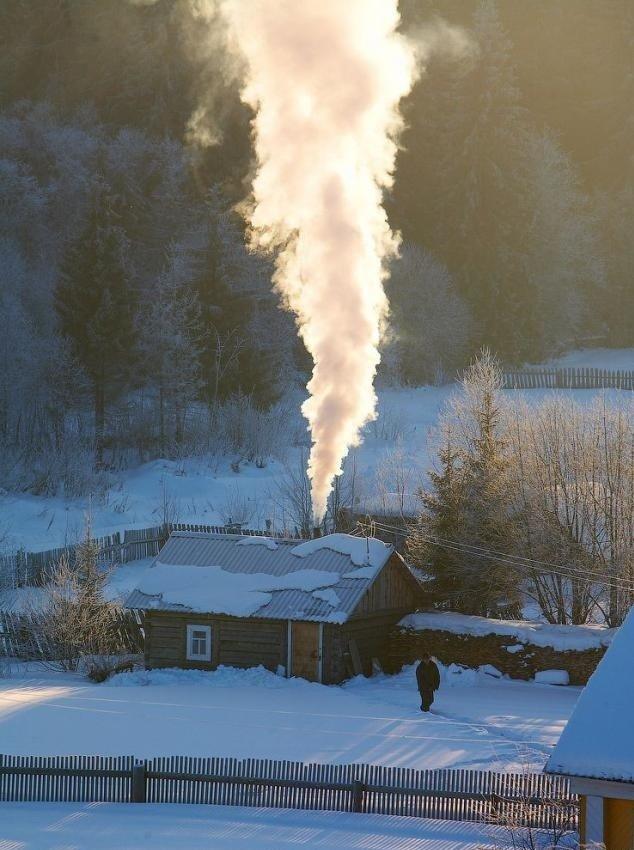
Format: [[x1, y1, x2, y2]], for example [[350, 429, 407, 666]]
[[545, 608, 634, 782]]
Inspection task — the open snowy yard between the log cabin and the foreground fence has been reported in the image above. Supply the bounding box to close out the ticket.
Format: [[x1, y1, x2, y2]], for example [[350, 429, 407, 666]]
[[0, 667, 579, 770]]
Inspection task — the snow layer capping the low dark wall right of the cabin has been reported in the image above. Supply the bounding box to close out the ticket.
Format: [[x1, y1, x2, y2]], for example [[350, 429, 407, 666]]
[[399, 611, 616, 651]]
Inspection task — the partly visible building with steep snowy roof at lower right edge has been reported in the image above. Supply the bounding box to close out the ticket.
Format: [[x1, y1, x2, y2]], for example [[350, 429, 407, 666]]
[[546, 608, 634, 850]]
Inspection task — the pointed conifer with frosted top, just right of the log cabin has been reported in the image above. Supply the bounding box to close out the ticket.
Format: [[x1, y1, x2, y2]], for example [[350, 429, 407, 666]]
[[414, 351, 520, 616]]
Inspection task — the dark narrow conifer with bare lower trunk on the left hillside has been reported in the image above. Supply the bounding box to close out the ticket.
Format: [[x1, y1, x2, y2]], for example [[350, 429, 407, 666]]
[[55, 183, 135, 466]]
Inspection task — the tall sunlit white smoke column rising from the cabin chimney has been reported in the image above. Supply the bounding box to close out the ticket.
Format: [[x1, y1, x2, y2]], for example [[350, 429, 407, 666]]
[[221, 0, 417, 518]]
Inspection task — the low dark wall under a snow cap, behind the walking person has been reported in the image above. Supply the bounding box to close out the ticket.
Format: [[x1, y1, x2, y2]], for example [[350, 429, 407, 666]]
[[388, 627, 605, 685]]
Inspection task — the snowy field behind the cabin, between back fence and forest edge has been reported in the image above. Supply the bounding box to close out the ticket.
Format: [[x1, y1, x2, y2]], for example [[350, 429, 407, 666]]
[[0, 349, 634, 551]]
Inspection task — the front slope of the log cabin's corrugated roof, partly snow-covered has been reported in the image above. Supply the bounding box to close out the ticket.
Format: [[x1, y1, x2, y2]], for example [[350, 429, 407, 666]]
[[126, 532, 393, 623]]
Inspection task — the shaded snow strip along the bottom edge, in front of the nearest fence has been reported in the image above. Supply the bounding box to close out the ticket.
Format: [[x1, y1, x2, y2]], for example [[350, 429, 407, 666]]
[[0, 803, 504, 850]]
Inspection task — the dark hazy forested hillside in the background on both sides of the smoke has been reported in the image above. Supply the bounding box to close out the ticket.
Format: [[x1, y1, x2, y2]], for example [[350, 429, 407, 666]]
[[0, 0, 634, 494]]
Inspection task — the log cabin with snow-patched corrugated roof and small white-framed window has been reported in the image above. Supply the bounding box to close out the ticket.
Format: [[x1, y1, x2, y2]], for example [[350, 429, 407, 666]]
[[126, 532, 423, 683]]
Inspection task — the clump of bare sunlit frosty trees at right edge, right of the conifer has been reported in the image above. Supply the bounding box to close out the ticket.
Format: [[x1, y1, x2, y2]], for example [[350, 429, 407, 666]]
[[506, 396, 634, 625]]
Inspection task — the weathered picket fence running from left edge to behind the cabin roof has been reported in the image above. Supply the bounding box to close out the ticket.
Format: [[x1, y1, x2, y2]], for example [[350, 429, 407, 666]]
[[0, 523, 284, 586]]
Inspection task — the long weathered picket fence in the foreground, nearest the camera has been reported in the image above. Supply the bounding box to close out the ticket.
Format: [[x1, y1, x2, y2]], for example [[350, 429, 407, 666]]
[[0, 755, 578, 830]]
